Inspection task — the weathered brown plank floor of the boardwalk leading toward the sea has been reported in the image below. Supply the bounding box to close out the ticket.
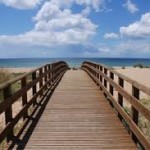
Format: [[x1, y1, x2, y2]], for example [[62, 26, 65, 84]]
[[25, 70, 136, 150]]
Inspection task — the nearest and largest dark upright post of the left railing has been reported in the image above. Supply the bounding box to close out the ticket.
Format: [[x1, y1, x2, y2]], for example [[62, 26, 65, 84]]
[[3, 85, 13, 142]]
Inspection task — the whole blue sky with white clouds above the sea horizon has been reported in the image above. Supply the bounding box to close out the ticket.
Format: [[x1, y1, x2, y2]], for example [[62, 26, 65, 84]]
[[0, 0, 150, 58]]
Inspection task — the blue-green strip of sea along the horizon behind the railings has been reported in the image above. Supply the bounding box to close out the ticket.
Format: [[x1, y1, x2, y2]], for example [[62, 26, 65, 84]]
[[0, 58, 150, 68]]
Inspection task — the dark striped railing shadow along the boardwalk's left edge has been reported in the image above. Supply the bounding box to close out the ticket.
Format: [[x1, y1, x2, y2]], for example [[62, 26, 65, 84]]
[[8, 83, 58, 150]]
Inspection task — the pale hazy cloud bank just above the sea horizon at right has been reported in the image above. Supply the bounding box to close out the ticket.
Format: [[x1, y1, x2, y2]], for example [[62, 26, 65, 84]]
[[91, 40, 150, 58]]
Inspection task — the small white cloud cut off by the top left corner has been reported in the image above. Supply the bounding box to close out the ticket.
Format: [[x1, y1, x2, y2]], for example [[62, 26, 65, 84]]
[[0, 0, 41, 9]]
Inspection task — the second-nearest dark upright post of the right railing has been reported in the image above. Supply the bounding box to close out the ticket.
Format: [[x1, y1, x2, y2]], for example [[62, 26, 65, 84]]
[[118, 77, 124, 121]]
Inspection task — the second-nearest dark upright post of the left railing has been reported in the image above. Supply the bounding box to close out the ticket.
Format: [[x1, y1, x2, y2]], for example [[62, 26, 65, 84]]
[[21, 77, 28, 120]]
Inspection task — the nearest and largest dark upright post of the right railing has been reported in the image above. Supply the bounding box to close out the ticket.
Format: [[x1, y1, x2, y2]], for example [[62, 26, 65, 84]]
[[132, 86, 140, 143]]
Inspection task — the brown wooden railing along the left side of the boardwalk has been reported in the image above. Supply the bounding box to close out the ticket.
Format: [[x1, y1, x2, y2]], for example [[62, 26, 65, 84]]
[[0, 61, 68, 143]]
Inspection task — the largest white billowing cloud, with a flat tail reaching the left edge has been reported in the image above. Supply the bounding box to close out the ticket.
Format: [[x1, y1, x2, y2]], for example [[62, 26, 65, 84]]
[[0, 1, 97, 46]]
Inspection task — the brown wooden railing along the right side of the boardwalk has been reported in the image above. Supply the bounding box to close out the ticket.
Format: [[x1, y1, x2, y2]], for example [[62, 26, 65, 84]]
[[81, 62, 150, 150]]
